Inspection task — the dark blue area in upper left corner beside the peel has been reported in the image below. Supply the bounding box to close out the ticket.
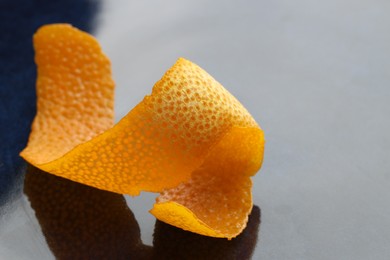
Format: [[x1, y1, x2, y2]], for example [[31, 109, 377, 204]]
[[0, 0, 99, 206]]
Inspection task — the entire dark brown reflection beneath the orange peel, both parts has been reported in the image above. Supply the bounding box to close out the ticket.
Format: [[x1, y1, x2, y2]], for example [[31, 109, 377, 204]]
[[24, 166, 261, 259]]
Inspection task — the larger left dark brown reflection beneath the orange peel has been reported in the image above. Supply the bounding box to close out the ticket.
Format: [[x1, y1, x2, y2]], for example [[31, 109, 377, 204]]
[[24, 166, 149, 259]]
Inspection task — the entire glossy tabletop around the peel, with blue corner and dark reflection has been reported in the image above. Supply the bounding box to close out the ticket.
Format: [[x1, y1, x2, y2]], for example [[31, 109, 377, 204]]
[[0, 0, 390, 259]]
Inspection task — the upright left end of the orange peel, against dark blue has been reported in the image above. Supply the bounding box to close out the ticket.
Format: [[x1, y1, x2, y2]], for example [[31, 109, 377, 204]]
[[21, 24, 114, 165]]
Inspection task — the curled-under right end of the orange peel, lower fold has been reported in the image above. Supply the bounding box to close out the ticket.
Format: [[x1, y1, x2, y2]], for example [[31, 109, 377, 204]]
[[151, 128, 264, 239]]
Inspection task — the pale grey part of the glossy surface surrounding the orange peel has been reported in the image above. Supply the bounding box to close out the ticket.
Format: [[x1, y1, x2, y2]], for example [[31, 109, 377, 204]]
[[0, 0, 390, 259]]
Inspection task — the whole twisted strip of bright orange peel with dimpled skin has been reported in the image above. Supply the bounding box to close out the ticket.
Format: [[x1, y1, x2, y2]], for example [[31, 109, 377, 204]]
[[21, 24, 264, 238]]
